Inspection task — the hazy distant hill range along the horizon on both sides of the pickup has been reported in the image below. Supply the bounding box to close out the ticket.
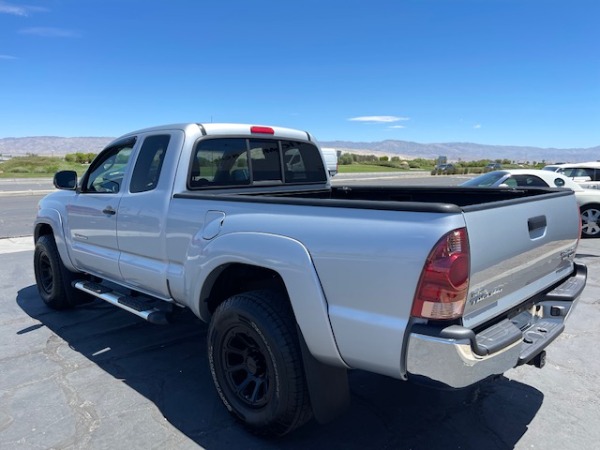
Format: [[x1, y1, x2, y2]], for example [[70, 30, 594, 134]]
[[0, 136, 600, 162]]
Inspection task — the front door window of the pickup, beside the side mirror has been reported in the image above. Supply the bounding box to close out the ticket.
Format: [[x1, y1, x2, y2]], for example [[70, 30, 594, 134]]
[[82, 138, 135, 193]]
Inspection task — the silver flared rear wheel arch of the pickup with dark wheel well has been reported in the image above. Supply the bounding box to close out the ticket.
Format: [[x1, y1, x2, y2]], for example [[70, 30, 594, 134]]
[[184, 232, 347, 367]]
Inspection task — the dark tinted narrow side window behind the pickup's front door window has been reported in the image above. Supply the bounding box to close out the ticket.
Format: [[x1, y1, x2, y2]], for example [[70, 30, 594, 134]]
[[129, 134, 171, 193]]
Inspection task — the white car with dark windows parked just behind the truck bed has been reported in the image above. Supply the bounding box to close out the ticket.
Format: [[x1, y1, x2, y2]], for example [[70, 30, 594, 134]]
[[461, 169, 600, 237]]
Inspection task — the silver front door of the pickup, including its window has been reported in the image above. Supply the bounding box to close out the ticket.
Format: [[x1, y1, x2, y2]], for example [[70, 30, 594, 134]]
[[65, 137, 136, 281]]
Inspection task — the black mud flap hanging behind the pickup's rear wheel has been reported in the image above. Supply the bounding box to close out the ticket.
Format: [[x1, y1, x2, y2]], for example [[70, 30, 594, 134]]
[[298, 328, 350, 424]]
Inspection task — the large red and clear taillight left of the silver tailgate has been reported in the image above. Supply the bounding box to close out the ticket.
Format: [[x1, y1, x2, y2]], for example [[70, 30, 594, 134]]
[[411, 228, 470, 320]]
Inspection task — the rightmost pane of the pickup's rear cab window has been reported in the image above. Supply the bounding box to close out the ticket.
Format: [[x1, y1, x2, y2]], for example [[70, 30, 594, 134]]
[[281, 141, 327, 183]]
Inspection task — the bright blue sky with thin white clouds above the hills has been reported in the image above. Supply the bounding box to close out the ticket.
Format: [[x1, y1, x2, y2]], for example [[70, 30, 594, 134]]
[[0, 0, 600, 148]]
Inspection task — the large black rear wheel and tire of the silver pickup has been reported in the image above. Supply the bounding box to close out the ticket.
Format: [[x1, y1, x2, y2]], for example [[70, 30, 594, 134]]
[[207, 291, 312, 436]]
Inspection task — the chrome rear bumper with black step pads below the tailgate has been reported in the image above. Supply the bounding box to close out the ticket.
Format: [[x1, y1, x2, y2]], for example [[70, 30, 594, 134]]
[[406, 264, 587, 388]]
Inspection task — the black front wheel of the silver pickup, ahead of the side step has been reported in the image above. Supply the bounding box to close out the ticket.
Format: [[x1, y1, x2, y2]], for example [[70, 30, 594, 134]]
[[33, 235, 88, 310]]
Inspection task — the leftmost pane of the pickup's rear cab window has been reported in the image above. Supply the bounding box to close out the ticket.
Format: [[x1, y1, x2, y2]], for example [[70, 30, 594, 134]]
[[188, 138, 250, 189]]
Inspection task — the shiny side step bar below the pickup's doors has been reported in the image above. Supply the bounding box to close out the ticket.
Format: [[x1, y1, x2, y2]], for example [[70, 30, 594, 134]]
[[73, 281, 173, 325]]
